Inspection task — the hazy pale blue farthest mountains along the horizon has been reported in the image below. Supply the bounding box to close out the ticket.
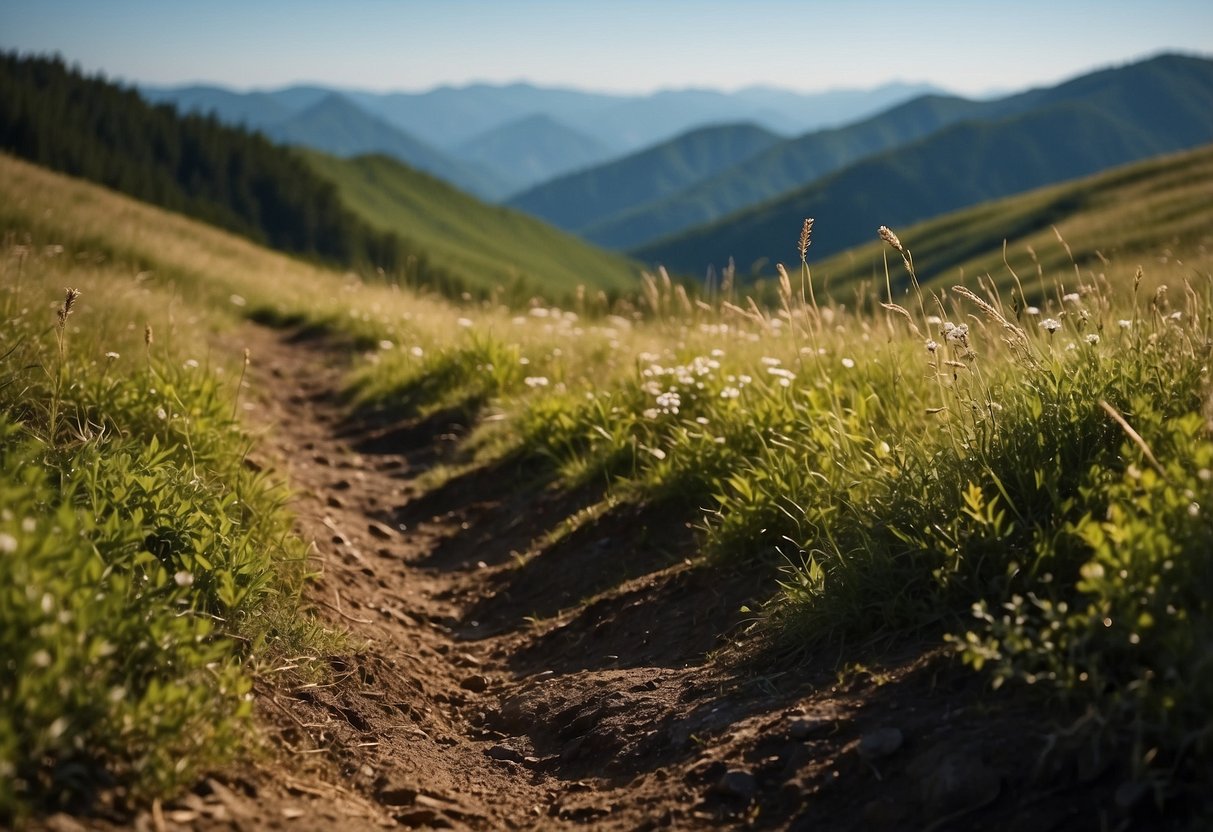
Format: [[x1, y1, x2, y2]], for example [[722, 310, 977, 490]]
[[141, 84, 938, 200]]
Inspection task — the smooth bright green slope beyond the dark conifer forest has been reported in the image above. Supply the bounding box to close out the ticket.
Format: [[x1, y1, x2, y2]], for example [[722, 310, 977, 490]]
[[304, 153, 639, 298]]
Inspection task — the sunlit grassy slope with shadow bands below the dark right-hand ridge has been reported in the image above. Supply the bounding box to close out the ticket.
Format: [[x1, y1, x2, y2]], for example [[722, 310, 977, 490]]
[[813, 146, 1213, 300]]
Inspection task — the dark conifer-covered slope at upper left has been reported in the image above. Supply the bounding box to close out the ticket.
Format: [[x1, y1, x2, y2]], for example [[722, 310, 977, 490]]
[[0, 53, 467, 292]]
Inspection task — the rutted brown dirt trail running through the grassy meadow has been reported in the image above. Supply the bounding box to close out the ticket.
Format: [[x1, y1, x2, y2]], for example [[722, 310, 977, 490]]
[[49, 329, 1188, 832]]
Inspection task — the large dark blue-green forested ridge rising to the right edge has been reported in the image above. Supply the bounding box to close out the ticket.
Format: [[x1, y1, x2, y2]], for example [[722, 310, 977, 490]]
[[633, 55, 1213, 274]]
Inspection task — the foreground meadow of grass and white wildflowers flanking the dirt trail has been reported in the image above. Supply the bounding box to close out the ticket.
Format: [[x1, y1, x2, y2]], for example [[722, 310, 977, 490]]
[[0, 151, 1213, 817]]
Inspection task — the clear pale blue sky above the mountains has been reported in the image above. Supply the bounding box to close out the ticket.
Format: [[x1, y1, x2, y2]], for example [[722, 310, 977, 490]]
[[0, 0, 1213, 93]]
